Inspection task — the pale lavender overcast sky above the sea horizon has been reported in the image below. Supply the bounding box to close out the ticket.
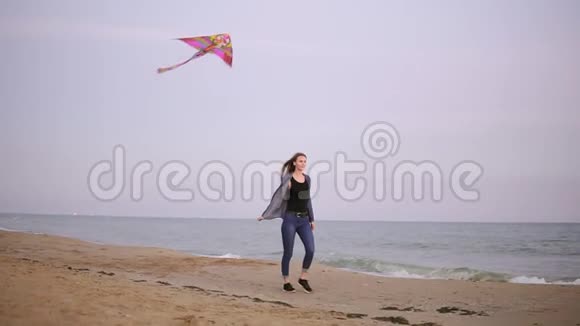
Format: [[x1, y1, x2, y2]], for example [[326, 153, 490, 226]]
[[0, 0, 580, 222]]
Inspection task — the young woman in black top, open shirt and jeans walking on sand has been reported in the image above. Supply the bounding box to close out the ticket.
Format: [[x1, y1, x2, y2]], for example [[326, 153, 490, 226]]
[[258, 153, 314, 293]]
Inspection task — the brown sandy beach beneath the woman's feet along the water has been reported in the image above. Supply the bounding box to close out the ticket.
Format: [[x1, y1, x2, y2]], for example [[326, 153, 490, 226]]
[[0, 231, 580, 326]]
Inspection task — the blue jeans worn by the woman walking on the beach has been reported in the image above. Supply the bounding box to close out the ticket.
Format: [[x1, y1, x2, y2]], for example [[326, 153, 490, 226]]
[[282, 212, 314, 276]]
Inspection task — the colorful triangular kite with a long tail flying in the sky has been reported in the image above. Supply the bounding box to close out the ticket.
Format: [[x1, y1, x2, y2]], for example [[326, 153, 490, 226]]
[[157, 34, 233, 73]]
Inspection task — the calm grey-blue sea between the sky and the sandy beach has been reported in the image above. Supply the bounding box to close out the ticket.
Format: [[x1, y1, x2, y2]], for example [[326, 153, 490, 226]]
[[0, 213, 580, 285]]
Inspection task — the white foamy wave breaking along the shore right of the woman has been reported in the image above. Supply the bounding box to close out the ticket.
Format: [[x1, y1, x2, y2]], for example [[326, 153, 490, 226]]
[[319, 257, 580, 285]]
